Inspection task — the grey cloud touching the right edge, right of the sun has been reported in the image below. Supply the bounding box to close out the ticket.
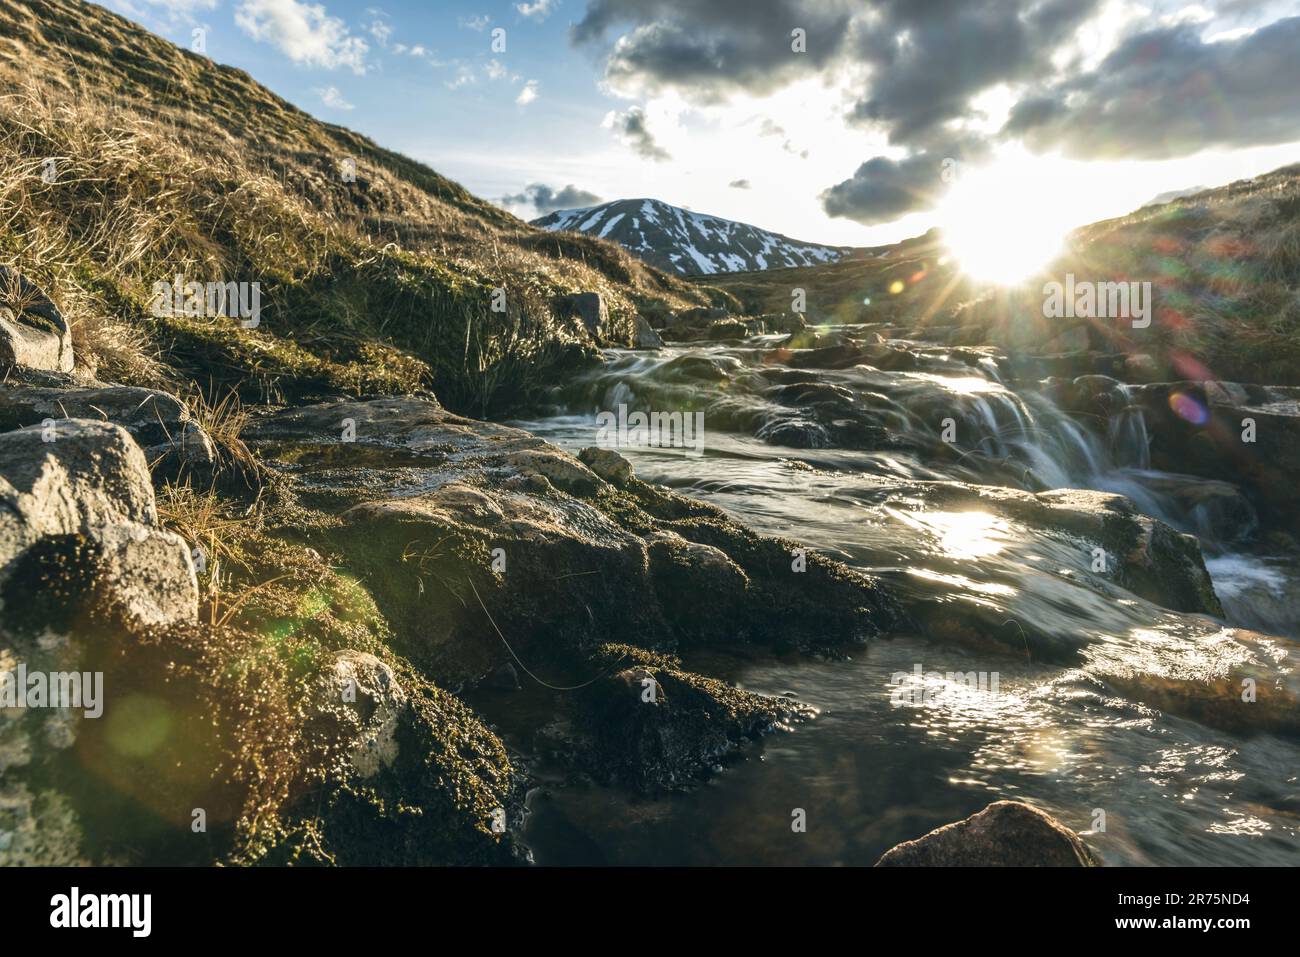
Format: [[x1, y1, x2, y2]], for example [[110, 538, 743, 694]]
[[1004, 17, 1300, 160]]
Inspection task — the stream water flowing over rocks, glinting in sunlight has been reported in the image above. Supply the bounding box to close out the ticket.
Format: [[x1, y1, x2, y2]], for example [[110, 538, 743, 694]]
[[481, 328, 1300, 865]]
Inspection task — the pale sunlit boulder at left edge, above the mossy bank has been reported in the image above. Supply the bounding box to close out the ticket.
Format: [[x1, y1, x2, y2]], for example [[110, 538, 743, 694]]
[[0, 419, 199, 628]]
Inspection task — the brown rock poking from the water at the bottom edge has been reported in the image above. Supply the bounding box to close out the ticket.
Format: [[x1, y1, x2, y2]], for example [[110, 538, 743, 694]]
[[876, 801, 1099, 867]]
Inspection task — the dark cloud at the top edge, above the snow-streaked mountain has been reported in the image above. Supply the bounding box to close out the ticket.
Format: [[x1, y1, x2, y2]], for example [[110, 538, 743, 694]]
[[572, 0, 863, 100]]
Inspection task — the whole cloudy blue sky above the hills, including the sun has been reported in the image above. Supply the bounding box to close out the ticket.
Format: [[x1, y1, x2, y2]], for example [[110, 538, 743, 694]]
[[104, 0, 1300, 259]]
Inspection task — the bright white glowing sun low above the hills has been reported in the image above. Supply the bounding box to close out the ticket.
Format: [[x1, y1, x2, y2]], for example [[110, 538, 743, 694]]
[[939, 157, 1075, 286]]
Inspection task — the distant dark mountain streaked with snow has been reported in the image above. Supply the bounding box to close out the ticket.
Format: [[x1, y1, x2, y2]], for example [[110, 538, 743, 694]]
[[533, 199, 850, 276]]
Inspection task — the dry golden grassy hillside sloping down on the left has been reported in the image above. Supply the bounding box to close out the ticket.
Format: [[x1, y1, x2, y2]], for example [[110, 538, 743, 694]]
[[0, 0, 707, 415]]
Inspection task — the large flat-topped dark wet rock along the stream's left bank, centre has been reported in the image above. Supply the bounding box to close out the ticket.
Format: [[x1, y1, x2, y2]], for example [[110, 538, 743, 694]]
[[248, 397, 897, 687]]
